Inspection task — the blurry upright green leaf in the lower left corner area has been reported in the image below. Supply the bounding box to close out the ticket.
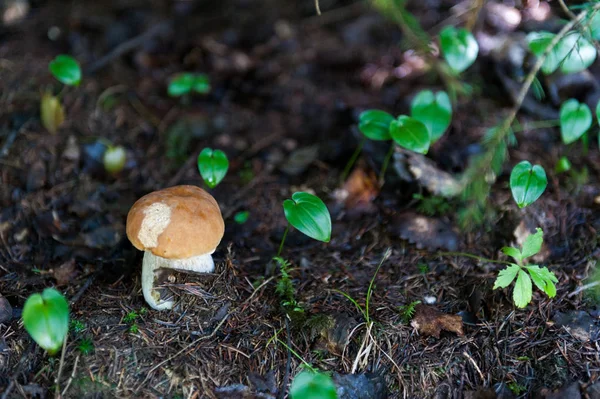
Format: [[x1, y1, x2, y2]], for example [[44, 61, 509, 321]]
[[22, 288, 69, 355]]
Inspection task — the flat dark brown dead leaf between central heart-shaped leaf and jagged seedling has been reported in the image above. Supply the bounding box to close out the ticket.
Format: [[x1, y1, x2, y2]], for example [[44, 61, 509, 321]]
[[389, 212, 459, 251]]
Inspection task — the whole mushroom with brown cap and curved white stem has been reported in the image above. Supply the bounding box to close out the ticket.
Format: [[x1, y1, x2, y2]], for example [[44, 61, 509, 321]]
[[127, 186, 225, 310]]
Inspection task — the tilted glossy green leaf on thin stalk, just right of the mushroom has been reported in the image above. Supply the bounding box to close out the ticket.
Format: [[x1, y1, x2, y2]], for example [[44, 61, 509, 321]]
[[283, 192, 331, 242]]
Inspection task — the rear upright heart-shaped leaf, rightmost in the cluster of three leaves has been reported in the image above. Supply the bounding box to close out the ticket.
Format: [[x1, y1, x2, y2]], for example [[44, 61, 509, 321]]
[[410, 90, 452, 143]]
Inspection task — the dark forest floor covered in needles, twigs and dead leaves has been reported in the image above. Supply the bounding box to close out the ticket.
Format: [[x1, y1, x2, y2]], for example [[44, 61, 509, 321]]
[[0, 0, 600, 399]]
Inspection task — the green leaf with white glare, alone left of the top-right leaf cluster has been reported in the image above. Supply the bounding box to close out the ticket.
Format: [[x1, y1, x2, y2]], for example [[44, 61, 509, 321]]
[[440, 25, 479, 73]]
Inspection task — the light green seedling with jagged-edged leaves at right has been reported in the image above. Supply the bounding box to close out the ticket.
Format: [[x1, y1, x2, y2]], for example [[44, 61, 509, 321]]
[[494, 228, 558, 308]]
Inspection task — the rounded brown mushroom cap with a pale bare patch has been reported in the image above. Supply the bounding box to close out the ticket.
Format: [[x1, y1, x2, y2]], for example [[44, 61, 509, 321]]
[[127, 186, 225, 259]]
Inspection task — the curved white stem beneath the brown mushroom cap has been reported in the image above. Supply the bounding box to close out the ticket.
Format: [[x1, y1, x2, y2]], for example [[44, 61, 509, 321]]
[[142, 251, 215, 310]]
